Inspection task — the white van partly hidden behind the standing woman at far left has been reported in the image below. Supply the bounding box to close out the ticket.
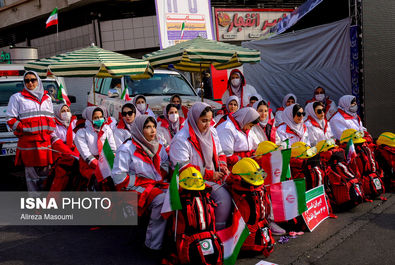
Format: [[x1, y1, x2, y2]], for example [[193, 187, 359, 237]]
[[0, 64, 75, 156]]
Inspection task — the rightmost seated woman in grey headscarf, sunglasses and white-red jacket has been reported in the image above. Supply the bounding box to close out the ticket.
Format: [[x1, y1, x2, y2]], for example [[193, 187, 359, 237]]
[[330, 95, 367, 140]]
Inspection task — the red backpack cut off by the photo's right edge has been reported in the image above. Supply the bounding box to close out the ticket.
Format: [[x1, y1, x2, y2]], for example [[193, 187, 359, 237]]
[[374, 145, 395, 192]]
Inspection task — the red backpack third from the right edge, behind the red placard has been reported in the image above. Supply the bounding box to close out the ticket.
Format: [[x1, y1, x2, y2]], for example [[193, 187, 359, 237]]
[[320, 148, 365, 206]]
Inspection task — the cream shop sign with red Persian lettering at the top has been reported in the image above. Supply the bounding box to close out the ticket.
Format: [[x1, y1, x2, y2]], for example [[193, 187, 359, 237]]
[[214, 8, 293, 41]]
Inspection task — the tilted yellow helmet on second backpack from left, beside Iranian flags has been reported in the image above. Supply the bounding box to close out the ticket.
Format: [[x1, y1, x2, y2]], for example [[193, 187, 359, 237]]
[[232, 157, 267, 186]]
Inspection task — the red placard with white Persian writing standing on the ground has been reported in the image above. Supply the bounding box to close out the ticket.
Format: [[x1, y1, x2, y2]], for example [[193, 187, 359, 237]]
[[302, 185, 329, 232]]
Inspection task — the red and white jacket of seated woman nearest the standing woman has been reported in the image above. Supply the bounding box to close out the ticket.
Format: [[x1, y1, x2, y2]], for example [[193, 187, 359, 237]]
[[51, 116, 79, 161]]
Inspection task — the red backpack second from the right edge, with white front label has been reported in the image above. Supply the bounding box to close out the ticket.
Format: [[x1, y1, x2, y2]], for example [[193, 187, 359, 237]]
[[352, 143, 385, 198]]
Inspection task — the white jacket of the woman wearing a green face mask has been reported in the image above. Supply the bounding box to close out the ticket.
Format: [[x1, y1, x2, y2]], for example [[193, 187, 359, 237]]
[[74, 120, 116, 164]]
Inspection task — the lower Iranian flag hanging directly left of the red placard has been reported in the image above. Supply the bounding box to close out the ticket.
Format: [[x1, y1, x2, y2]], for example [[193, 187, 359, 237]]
[[270, 179, 307, 222]]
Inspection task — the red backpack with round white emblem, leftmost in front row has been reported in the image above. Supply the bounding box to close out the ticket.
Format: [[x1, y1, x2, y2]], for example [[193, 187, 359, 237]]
[[170, 187, 223, 264]]
